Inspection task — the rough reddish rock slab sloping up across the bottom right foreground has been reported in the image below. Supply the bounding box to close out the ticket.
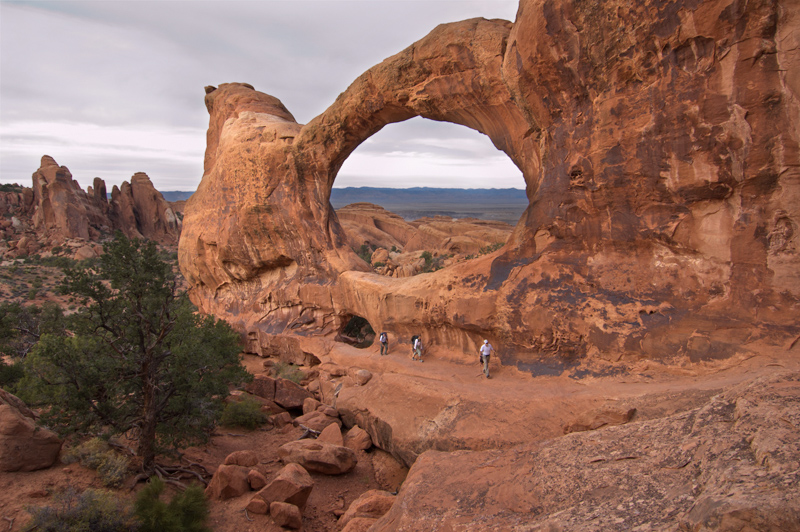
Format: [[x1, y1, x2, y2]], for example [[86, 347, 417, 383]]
[[370, 373, 800, 531]]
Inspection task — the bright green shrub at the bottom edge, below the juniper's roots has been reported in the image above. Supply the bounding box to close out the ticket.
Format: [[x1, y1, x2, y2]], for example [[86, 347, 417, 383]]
[[134, 477, 212, 532]]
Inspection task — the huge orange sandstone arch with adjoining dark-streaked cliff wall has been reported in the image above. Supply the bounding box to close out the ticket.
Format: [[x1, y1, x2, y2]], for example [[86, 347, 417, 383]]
[[179, 0, 800, 364]]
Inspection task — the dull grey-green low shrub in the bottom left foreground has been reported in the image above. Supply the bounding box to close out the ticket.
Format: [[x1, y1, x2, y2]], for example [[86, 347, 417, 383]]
[[23, 489, 139, 532]]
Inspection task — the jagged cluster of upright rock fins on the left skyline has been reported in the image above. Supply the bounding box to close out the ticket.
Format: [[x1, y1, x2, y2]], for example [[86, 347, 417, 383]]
[[26, 155, 181, 244]]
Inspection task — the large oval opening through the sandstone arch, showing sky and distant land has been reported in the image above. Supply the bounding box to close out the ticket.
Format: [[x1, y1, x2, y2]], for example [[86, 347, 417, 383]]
[[330, 117, 528, 277]]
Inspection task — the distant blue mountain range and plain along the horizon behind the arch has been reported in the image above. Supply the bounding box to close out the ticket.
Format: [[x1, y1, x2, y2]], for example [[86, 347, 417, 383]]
[[161, 187, 528, 224]]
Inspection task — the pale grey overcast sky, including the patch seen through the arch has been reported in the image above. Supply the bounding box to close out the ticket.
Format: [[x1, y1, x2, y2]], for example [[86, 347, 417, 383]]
[[0, 0, 524, 190]]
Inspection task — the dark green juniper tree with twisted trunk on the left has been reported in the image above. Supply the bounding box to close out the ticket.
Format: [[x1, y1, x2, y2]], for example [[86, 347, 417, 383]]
[[24, 233, 248, 471]]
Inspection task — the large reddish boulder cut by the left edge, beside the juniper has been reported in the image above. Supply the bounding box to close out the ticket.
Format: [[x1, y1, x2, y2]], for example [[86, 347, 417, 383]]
[[0, 389, 61, 472]]
